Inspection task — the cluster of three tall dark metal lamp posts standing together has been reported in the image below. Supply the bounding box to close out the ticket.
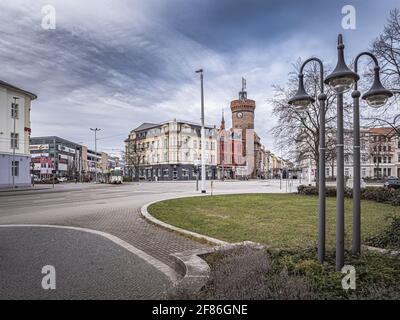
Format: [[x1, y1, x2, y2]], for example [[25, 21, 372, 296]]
[[288, 34, 393, 270]]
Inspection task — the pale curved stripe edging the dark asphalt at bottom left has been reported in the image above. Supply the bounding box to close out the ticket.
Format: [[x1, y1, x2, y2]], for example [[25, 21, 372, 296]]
[[0, 224, 179, 285]]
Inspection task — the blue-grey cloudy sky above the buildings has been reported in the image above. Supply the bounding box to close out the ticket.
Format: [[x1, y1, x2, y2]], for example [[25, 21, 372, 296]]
[[0, 0, 400, 154]]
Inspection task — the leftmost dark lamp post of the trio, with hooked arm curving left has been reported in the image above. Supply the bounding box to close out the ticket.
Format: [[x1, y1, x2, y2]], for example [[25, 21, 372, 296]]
[[288, 58, 327, 262]]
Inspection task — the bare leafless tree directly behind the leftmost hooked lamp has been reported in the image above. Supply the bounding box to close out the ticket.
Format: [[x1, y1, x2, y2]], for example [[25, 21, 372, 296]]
[[270, 60, 349, 181]]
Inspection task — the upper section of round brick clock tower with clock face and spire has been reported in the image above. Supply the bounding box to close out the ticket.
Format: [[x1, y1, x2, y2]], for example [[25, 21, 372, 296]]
[[231, 78, 256, 130]]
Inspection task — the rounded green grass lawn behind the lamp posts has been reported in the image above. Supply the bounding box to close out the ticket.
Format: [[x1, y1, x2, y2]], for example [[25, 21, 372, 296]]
[[149, 194, 400, 249]]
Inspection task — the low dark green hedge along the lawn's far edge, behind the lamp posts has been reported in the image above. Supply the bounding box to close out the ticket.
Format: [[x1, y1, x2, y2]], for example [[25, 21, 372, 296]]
[[297, 185, 400, 206]]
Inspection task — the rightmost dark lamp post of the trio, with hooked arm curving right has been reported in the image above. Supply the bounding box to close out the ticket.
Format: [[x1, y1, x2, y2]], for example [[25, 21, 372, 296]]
[[351, 52, 393, 255]]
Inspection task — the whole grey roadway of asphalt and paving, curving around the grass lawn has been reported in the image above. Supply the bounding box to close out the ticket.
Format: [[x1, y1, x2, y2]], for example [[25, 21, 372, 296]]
[[0, 181, 295, 299]]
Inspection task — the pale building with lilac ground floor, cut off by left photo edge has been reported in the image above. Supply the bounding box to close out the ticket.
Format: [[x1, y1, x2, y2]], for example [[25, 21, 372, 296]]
[[0, 81, 37, 188]]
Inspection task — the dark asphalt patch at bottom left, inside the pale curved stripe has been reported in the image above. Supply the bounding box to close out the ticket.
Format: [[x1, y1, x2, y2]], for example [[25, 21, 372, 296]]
[[0, 227, 171, 299]]
